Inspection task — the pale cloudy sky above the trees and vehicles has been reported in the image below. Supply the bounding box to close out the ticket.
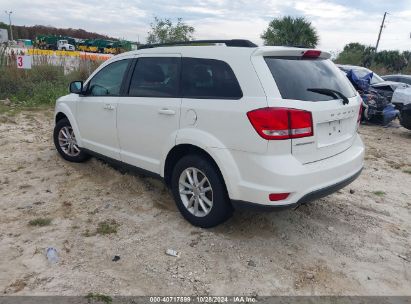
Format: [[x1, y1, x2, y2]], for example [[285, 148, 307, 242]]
[[0, 0, 411, 53]]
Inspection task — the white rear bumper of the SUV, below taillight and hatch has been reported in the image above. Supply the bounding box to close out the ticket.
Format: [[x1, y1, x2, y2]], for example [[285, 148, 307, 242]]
[[214, 134, 364, 208]]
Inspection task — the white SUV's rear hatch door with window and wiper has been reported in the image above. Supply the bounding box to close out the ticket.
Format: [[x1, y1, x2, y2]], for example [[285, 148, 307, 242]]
[[264, 52, 361, 163]]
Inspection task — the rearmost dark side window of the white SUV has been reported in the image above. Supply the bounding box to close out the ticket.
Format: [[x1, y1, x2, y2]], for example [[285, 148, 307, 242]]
[[182, 58, 243, 99]]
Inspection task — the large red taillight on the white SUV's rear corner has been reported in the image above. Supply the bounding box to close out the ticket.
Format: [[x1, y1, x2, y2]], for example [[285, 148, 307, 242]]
[[247, 108, 314, 140]]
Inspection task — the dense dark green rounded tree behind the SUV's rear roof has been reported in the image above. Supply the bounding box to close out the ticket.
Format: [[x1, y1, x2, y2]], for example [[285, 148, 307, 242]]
[[261, 16, 319, 48]]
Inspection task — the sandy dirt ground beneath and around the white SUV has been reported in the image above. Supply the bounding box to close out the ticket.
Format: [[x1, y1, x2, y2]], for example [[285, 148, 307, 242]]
[[0, 111, 411, 295]]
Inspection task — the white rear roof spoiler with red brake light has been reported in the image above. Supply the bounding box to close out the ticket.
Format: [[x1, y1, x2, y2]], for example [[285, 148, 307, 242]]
[[252, 46, 331, 59]]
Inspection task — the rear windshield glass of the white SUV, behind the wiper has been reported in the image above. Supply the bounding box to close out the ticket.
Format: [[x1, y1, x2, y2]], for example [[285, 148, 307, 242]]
[[264, 57, 355, 101]]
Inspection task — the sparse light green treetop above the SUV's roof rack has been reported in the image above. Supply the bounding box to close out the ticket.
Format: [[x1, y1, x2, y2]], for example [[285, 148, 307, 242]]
[[147, 17, 195, 44]]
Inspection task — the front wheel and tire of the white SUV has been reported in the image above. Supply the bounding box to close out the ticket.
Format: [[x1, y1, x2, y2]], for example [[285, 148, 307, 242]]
[[53, 118, 90, 163]]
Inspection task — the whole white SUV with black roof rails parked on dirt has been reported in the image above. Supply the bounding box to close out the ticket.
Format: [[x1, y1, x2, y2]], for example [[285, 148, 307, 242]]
[[54, 40, 364, 227]]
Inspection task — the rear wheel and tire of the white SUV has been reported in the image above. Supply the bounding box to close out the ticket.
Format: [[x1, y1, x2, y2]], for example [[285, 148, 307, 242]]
[[171, 155, 233, 228]]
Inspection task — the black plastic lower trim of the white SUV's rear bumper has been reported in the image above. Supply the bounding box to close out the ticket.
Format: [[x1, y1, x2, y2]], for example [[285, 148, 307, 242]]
[[231, 168, 362, 211]]
